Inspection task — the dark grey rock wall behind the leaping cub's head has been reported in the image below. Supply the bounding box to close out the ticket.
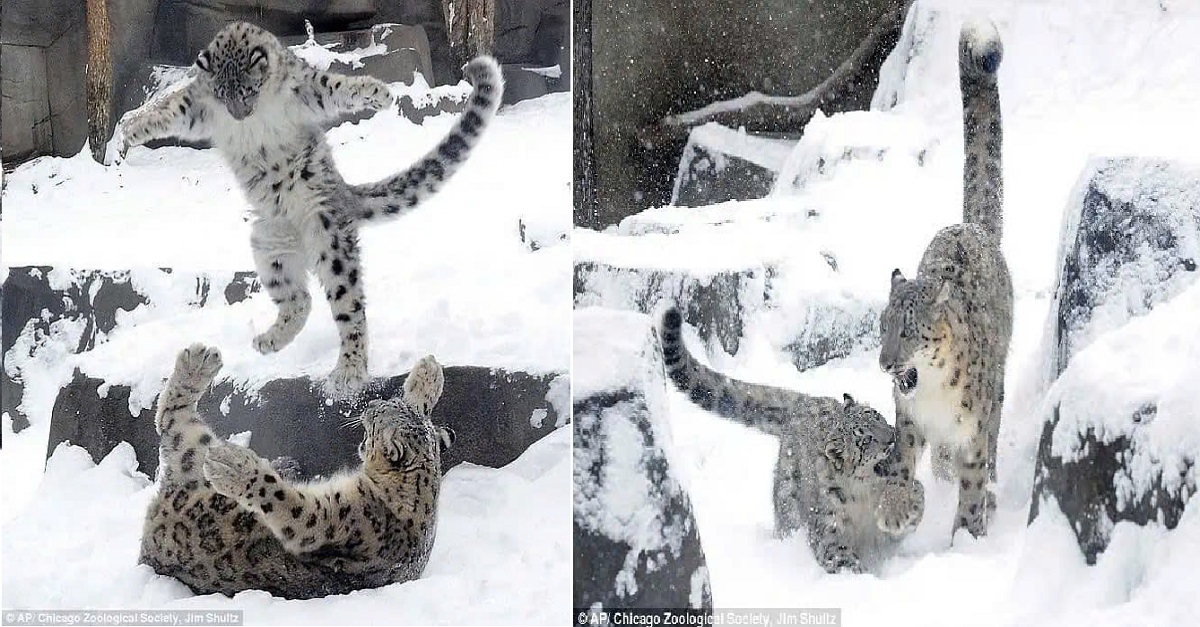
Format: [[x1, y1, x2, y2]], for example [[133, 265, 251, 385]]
[[0, 0, 570, 162]]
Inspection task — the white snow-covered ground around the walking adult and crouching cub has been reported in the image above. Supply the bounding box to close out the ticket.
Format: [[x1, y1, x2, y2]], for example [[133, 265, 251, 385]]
[[583, 0, 1200, 626]]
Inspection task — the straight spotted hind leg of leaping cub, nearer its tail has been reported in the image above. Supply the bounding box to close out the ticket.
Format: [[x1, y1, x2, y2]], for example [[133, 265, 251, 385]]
[[307, 209, 367, 396]]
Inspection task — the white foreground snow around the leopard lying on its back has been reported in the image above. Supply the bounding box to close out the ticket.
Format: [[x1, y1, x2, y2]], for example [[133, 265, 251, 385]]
[[2, 427, 571, 625]]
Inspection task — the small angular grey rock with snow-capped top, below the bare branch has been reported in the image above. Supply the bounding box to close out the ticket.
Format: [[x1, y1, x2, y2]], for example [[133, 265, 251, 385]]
[[671, 123, 796, 207]]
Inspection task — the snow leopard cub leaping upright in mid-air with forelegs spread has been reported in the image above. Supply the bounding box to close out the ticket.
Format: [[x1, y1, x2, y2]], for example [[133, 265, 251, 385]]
[[122, 23, 504, 395]]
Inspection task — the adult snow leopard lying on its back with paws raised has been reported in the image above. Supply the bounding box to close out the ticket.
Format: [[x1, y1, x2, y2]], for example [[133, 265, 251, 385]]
[[139, 344, 455, 598]]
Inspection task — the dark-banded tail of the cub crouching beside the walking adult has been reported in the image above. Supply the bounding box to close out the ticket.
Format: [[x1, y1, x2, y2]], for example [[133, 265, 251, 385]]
[[659, 307, 836, 435]]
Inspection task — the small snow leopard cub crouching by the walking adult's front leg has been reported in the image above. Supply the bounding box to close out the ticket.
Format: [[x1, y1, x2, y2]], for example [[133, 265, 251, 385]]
[[660, 309, 925, 573]]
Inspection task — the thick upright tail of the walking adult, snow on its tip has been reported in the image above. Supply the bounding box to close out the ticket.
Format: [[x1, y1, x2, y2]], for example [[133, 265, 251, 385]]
[[959, 20, 1004, 241]]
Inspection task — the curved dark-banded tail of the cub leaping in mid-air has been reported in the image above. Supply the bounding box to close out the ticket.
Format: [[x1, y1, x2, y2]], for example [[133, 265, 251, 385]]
[[352, 56, 504, 222]]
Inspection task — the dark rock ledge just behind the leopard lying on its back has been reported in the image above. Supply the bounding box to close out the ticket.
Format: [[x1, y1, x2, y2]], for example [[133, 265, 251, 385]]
[[47, 366, 569, 478]]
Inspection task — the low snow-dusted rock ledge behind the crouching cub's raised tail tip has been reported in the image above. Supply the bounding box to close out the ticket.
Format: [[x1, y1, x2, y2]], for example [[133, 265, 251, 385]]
[[575, 256, 773, 354]]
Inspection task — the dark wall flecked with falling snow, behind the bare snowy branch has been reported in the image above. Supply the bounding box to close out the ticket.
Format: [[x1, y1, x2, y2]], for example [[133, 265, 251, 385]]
[[575, 0, 904, 228]]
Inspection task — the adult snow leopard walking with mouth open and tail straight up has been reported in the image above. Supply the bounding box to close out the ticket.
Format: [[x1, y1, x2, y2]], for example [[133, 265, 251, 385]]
[[880, 22, 1013, 537]]
